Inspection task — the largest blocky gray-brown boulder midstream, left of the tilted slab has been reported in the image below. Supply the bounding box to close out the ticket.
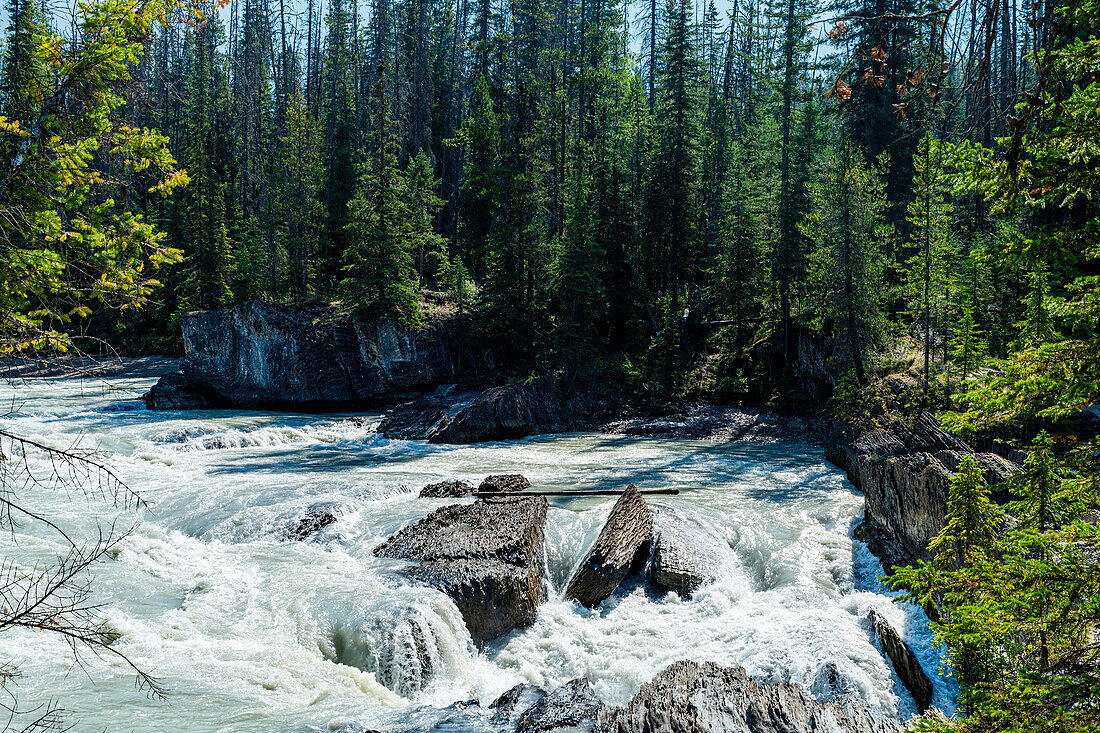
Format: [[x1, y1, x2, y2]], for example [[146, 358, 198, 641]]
[[374, 496, 548, 644]]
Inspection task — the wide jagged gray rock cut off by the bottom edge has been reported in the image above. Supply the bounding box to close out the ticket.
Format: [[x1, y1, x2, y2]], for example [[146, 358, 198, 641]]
[[596, 661, 904, 733]]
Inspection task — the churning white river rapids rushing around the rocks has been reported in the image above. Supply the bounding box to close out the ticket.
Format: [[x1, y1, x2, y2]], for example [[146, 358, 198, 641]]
[[0, 379, 955, 733]]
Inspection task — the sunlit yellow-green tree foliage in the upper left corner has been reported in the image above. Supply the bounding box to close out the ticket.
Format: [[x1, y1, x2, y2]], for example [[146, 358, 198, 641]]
[[0, 0, 188, 354]]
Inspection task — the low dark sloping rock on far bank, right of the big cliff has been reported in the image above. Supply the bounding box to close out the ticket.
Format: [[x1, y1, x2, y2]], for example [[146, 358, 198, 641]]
[[429, 375, 593, 444]]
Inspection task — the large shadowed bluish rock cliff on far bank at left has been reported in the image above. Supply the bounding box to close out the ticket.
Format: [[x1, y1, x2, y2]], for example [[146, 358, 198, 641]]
[[146, 302, 470, 411]]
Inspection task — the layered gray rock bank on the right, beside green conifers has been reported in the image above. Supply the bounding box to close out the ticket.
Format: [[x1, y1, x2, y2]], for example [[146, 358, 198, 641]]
[[825, 375, 1018, 564]]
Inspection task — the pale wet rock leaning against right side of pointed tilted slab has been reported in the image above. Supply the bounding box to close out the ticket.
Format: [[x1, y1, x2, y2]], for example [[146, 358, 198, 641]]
[[649, 507, 736, 598]]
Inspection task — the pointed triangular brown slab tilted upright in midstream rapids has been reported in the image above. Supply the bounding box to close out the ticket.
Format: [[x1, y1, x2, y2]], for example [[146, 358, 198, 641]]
[[565, 483, 653, 608]]
